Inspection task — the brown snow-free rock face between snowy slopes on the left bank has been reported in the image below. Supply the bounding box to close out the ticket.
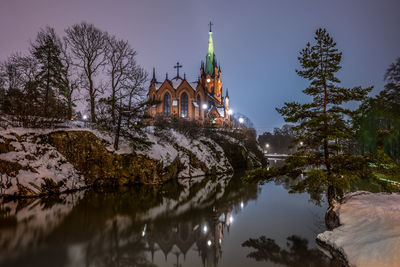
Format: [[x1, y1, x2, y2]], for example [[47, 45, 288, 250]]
[[47, 131, 172, 185]]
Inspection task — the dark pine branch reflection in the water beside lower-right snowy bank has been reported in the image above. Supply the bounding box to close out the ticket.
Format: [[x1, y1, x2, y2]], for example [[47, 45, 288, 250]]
[[242, 235, 341, 267]]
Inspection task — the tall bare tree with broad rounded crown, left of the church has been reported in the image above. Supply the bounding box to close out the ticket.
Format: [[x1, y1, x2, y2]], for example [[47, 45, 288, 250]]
[[66, 22, 107, 122]]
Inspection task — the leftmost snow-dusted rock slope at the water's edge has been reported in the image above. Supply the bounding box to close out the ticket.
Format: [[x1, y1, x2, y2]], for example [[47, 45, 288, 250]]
[[0, 130, 85, 196]]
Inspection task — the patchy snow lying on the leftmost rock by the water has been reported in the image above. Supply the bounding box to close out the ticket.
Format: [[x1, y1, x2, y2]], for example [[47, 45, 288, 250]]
[[0, 128, 86, 195]]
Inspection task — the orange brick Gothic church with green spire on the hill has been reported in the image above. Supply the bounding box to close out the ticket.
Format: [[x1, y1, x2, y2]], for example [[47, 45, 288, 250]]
[[147, 22, 232, 127]]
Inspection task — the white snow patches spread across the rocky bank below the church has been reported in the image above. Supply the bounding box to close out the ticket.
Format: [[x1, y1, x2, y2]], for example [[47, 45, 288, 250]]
[[0, 118, 236, 195]]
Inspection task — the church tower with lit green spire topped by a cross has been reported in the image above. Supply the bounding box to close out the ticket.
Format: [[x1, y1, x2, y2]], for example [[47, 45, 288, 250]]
[[200, 22, 223, 103]]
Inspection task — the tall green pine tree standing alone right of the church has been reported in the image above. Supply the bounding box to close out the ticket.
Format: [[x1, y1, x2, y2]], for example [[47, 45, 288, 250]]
[[277, 29, 372, 206]]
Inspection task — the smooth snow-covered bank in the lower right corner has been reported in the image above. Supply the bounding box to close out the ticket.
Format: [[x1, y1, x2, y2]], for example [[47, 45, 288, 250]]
[[317, 192, 400, 266]]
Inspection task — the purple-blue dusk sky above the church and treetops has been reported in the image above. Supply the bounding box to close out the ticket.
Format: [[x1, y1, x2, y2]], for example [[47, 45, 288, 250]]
[[0, 0, 400, 134]]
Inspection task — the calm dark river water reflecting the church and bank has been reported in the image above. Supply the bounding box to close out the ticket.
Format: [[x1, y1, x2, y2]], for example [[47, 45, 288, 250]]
[[0, 173, 336, 267]]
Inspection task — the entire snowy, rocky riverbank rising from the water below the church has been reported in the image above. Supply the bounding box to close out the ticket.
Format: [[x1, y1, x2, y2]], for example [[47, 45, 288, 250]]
[[0, 120, 263, 197]]
